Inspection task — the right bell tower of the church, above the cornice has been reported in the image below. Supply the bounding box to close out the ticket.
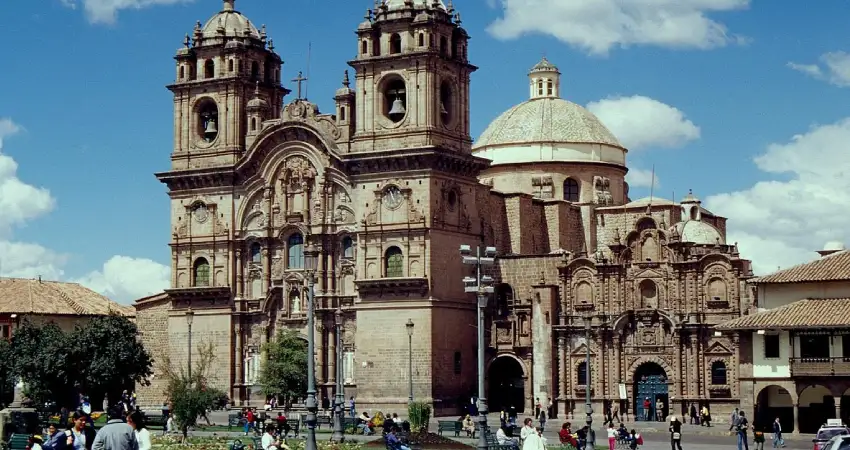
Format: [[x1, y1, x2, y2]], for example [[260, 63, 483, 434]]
[[349, 0, 476, 153]]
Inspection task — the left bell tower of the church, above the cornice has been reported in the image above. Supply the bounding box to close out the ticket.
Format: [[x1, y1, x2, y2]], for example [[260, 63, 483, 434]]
[[168, 0, 289, 170]]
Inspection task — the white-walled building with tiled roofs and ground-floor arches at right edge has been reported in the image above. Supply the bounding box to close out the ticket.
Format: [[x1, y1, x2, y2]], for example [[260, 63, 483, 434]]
[[718, 242, 850, 433]]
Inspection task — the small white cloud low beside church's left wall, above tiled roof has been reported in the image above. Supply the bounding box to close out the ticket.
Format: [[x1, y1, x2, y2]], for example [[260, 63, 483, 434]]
[[75, 255, 171, 303]]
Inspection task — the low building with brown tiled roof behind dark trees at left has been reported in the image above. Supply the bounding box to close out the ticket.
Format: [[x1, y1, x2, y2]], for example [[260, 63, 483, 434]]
[[0, 277, 135, 339]]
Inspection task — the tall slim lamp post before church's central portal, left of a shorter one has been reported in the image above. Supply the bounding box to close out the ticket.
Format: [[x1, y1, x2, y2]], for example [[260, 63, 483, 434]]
[[304, 244, 319, 450]]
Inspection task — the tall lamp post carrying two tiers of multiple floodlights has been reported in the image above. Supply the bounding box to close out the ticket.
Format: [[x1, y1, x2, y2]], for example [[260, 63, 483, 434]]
[[460, 245, 496, 450]]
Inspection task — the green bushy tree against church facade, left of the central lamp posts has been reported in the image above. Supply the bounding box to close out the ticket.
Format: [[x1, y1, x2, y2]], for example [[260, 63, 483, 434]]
[[260, 330, 307, 399]]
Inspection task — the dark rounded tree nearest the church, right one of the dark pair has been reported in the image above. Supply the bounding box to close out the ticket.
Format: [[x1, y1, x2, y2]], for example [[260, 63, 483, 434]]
[[70, 315, 153, 406]]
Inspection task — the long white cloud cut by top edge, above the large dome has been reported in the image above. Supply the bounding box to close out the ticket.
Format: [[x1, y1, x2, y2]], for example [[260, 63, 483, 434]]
[[488, 0, 750, 55]]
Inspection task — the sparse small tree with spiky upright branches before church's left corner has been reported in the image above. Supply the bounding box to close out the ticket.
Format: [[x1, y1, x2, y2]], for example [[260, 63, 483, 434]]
[[162, 343, 227, 441]]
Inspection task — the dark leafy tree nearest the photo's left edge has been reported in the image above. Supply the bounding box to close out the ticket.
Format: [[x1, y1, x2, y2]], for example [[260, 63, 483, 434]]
[[11, 320, 73, 407]]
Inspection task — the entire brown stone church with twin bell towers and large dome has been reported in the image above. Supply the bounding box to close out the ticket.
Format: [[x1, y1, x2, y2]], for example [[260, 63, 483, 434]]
[[135, 0, 752, 420]]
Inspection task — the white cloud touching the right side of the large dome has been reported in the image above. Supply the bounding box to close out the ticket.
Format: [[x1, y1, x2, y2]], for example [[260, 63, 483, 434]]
[[587, 95, 700, 150]]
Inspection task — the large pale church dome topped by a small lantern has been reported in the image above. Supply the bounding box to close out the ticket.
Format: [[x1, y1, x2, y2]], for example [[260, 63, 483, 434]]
[[473, 58, 626, 166]]
